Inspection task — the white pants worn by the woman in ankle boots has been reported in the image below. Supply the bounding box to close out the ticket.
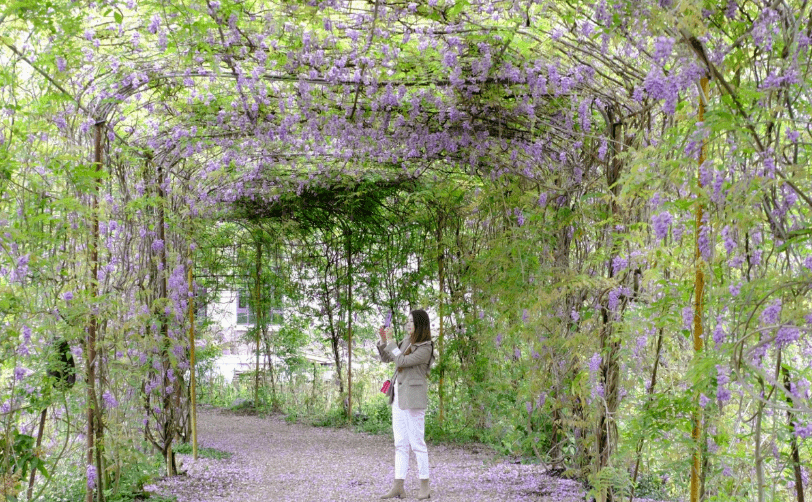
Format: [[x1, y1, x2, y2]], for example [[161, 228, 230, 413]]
[[392, 382, 429, 479]]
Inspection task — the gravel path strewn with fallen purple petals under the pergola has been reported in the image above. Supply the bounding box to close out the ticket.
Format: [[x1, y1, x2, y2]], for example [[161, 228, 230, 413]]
[[150, 409, 583, 502]]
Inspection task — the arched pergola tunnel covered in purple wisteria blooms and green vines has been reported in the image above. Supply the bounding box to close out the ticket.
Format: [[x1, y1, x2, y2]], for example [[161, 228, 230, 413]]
[[0, 0, 812, 502]]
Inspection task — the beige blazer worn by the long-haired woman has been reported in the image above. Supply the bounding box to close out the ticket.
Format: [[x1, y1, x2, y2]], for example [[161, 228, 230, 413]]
[[377, 338, 434, 410]]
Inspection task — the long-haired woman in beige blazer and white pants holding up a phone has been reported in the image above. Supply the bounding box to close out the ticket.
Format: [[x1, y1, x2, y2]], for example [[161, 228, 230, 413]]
[[378, 310, 434, 500]]
